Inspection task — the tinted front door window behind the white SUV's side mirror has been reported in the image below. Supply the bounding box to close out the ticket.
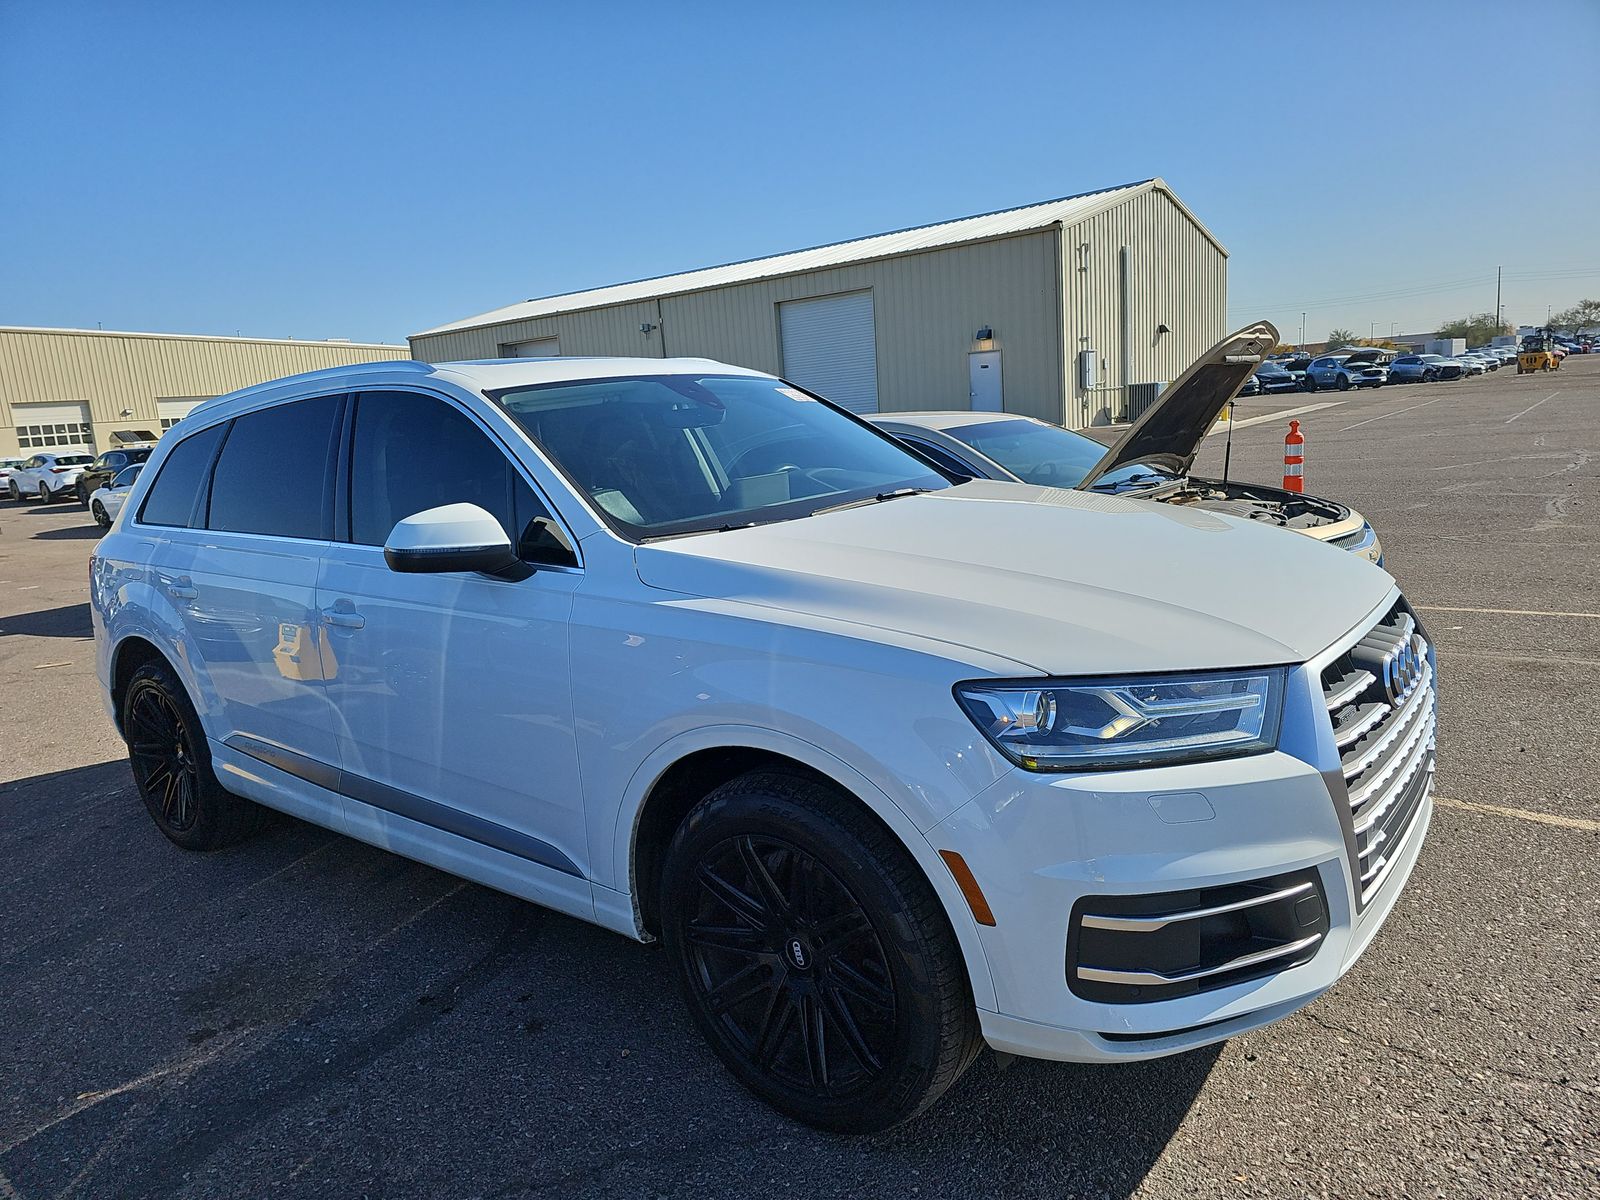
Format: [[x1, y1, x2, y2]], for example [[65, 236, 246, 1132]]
[[350, 392, 573, 562]]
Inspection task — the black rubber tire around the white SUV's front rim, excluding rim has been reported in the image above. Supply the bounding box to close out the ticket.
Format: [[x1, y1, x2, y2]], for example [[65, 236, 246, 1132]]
[[661, 774, 971, 1133]]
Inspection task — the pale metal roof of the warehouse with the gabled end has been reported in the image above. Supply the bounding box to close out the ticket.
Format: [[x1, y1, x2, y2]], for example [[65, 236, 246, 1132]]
[[411, 179, 1227, 338]]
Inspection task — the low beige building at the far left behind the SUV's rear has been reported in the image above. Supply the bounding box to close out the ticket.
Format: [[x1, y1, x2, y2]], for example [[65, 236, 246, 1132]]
[[0, 326, 410, 458]]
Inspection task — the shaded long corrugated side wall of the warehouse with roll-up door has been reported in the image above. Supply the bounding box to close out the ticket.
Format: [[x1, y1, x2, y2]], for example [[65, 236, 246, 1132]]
[[411, 230, 1062, 419]]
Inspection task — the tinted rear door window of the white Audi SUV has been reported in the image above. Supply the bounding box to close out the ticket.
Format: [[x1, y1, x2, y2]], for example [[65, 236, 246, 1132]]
[[208, 395, 341, 538]]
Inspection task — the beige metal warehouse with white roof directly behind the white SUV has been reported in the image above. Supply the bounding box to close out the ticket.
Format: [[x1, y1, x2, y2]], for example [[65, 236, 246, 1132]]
[[411, 179, 1227, 427]]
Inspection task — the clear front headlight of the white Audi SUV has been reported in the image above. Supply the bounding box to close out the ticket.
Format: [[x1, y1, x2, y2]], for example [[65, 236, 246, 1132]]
[[955, 667, 1285, 771]]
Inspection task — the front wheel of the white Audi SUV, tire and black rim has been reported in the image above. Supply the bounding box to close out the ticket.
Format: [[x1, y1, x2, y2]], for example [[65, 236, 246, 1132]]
[[661, 771, 981, 1133]]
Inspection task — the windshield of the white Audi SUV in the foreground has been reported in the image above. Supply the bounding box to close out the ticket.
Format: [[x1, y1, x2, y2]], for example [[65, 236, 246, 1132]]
[[490, 374, 950, 539]]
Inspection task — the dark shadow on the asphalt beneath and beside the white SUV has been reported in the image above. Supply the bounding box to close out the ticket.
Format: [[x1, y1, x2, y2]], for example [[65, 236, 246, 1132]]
[[0, 760, 1219, 1198]]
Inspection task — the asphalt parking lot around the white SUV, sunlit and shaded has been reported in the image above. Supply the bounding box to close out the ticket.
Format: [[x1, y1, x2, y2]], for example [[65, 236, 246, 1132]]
[[0, 355, 1600, 1200]]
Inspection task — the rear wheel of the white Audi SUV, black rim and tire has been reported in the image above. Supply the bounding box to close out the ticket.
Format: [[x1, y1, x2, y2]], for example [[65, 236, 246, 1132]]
[[120, 661, 270, 850]]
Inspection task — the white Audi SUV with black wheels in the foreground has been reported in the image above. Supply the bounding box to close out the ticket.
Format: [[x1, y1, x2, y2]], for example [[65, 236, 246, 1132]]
[[91, 326, 1434, 1130]]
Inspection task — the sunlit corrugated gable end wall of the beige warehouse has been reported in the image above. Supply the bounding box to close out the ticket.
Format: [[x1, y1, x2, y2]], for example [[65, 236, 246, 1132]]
[[1061, 189, 1227, 427]]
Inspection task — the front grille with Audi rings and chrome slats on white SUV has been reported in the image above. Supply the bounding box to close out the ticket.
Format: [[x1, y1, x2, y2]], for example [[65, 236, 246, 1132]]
[[1322, 600, 1438, 909]]
